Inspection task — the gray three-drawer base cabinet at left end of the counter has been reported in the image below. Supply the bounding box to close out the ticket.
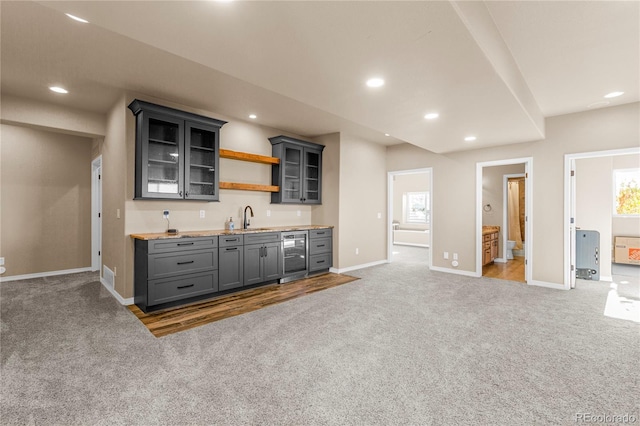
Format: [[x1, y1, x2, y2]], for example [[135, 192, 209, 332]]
[[134, 237, 219, 312]]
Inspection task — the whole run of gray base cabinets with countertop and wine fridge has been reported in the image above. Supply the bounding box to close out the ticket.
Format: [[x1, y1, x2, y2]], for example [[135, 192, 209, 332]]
[[131, 225, 333, 312]]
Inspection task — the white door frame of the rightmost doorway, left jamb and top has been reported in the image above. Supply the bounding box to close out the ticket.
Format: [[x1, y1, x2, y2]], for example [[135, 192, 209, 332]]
[[563, 147, 640, 290]]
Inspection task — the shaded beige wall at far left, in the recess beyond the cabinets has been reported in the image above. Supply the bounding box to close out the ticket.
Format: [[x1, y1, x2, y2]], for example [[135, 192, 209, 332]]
[[0, 124, 92, 277]]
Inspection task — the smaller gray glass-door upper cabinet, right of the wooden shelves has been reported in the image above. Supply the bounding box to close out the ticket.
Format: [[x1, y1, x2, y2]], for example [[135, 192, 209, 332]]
[[269, 136, 324, 204]]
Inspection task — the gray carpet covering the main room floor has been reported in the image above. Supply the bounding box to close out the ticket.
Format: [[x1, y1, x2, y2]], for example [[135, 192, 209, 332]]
[[0, 249, 640, 425]]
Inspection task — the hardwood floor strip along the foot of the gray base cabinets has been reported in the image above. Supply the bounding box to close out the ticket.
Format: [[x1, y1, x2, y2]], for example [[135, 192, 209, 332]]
[[128, 273, 358, 337]]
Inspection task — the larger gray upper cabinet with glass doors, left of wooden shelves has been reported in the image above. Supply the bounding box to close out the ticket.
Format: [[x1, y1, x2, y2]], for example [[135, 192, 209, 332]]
[[129, 99, 226, 201]]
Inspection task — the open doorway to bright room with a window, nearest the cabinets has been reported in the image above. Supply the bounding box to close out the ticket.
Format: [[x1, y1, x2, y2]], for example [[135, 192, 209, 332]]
[[387, 168, 433, 266]]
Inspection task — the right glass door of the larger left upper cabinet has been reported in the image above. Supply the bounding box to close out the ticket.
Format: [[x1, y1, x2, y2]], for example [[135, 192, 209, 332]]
[[185, 121, 219, 201]]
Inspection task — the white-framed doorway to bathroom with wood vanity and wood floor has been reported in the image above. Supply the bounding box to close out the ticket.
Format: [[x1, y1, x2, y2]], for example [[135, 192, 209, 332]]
[[476, 157, 533, 284]]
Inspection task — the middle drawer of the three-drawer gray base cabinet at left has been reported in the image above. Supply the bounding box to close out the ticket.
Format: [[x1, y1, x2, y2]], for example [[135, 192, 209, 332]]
[[149, 249, 218, 280]]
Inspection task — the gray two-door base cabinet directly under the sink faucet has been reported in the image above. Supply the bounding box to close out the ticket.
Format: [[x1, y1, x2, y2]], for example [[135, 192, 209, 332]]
[[244, 232, 282, 286]]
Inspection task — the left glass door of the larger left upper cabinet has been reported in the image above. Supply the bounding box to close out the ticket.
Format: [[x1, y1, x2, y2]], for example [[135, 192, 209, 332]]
[[136, 114, 184, 198]]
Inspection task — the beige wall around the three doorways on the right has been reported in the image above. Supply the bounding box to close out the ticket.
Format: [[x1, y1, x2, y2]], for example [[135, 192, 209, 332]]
[[387, 103, 640, 284]]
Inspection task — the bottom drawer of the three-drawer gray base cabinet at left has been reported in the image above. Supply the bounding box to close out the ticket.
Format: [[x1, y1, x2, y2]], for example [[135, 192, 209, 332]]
[[147, 271, 218, 305]]
